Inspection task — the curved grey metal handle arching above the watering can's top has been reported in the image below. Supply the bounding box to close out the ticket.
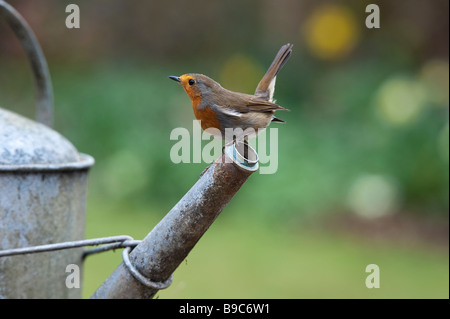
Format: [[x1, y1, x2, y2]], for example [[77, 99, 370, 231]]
[[0, 0, 53, 127]]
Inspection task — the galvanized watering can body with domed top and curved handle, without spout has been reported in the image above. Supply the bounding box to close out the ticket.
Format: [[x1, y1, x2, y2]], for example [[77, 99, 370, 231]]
[[0, 0, 94, 299]]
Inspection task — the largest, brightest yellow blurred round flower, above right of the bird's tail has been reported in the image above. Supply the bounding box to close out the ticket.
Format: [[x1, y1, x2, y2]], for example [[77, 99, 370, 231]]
[[303, 4, 359, 60]]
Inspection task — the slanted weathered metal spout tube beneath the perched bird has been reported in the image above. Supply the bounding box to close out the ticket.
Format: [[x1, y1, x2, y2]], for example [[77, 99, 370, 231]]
[[92, 150, 252, 299]]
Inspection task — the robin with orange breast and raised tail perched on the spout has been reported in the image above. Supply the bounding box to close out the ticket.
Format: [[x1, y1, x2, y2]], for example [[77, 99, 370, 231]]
[[169, 43, 293, 141]]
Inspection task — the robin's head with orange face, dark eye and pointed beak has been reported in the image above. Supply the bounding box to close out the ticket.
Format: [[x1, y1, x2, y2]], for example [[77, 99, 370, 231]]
[[169, 73, 221, 101]]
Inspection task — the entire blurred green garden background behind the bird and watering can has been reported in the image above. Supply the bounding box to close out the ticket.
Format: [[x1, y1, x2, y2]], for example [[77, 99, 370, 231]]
[[0, 0, 449, 298]]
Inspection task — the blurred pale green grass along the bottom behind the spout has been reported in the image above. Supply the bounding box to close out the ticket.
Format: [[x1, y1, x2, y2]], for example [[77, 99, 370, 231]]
[[83, 200, 449, 299]]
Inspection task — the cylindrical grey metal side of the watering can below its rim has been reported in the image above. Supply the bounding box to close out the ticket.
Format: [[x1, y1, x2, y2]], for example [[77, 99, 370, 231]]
[[0, 169, 87, 298]]
